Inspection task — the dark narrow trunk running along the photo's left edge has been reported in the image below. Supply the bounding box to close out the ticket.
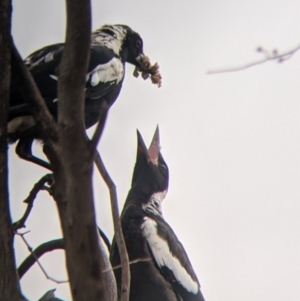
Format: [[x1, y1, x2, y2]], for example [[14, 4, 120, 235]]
[[0, 0, 21, 301]]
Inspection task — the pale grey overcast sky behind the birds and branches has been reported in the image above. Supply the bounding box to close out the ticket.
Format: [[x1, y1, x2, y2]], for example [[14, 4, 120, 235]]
[[9, 0, 300, 301]]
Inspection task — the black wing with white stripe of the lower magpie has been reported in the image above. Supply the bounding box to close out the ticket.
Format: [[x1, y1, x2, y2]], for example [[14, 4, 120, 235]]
[[142, 217, 204, 301]]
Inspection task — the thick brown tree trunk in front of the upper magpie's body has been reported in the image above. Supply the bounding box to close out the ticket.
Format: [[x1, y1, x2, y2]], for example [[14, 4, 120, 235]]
[[46, 0, 107, 301]]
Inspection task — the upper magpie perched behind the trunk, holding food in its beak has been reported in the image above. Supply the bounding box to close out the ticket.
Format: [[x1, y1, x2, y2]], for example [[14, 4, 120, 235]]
[[8, 25, 161, 169]]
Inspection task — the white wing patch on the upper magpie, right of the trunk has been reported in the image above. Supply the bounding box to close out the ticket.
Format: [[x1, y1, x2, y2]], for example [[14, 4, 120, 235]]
[[86, 58, 124, 86]]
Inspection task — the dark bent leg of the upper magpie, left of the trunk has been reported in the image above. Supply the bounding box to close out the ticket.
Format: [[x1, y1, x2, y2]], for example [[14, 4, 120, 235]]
[[16, 138, 52, 170]]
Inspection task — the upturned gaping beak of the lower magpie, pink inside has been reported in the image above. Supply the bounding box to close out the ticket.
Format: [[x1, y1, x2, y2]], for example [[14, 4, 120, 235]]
[[137, 126, 160, 165]]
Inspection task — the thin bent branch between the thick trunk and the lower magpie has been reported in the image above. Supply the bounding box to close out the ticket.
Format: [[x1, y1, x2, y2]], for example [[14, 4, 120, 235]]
[[95, 151, 130, 301]]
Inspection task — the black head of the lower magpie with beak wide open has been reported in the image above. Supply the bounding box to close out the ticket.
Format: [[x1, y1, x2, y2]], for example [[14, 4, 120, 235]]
[[132, 127, 169, 198]]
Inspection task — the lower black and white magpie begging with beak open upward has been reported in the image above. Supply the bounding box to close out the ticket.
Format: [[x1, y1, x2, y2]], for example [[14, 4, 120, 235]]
[[111, 128, 204, 301]]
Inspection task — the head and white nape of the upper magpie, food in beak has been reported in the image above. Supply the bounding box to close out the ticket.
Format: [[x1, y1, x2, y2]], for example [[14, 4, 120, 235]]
[[92, 24, 162, 87]]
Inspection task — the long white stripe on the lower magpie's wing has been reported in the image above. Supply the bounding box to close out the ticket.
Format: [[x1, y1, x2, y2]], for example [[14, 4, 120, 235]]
[[141, 217, 199, 295]]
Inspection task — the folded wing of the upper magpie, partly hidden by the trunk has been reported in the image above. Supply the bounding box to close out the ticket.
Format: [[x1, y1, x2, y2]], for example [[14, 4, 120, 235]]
[[10, 44, 124, 116]]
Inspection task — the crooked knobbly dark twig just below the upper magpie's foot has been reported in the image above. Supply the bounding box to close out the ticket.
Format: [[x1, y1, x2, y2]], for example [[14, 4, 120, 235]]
[[13, 174, 52, 231]]
